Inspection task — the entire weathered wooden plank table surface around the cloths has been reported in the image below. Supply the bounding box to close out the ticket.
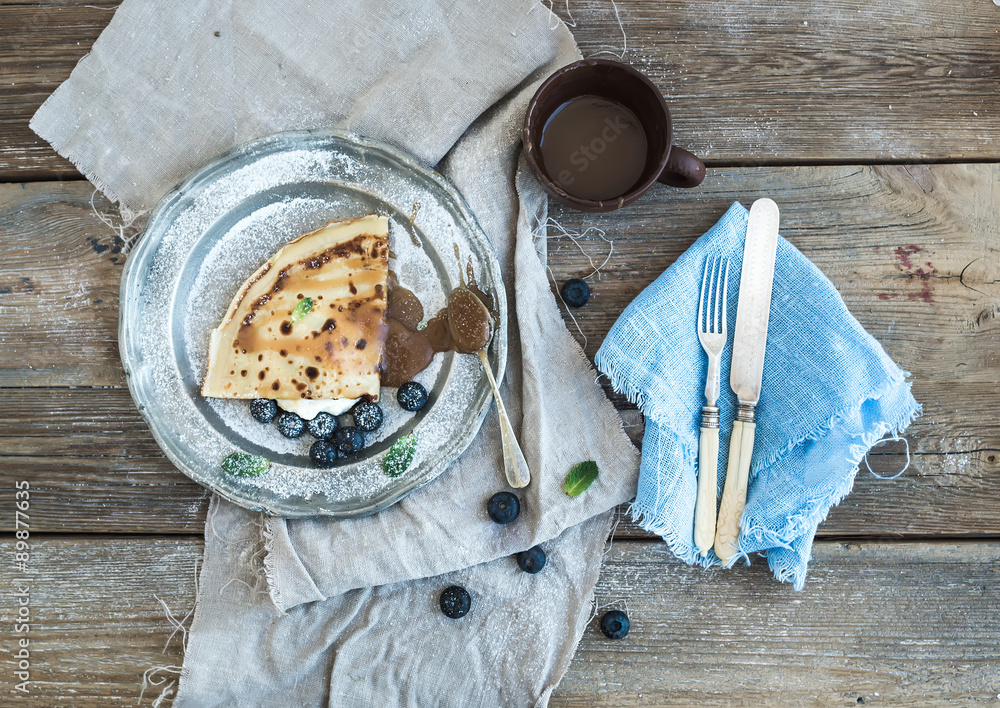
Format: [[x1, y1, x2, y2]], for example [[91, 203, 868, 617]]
[[0, 0, 1000, 707]]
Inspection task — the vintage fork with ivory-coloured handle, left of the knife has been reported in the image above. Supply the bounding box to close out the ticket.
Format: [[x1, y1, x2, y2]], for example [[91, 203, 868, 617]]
[[694, 256, 729, 557]]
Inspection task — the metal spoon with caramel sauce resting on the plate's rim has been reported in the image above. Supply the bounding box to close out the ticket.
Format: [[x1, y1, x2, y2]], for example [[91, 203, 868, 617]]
[[448, 286, 531, 489]]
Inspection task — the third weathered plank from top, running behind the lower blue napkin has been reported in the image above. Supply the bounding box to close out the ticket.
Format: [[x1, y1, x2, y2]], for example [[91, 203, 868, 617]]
[[0, 388, 1000, 537]]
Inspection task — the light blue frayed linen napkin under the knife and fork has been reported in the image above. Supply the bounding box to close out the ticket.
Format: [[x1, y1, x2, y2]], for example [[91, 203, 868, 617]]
[[596, 202, 920, 590]]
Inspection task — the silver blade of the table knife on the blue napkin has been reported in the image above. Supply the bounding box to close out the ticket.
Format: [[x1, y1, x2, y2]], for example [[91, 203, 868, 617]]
[[729, 199, 779, 404]]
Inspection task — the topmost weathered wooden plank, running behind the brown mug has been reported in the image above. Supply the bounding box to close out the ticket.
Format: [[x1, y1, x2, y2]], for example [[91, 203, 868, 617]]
[[0, 0, 1000, 181]]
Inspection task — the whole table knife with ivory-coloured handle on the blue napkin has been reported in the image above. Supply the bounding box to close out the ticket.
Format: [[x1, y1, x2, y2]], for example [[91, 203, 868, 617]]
[[715, 199, 778, 565]]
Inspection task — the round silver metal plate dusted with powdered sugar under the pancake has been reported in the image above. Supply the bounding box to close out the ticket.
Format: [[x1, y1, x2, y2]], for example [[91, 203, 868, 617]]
[[119, 131, 507, 517]]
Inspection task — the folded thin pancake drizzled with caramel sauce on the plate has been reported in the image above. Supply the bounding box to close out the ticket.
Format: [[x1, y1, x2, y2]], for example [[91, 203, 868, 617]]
[[201, 216, 389, 400]]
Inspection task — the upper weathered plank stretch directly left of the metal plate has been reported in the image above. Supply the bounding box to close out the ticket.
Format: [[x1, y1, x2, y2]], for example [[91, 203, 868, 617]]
[[0, 181, 131, 386]]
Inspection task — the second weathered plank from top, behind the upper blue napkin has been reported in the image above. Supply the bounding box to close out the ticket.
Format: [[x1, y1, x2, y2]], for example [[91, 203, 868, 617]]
[[0, 165, 1000, 392]]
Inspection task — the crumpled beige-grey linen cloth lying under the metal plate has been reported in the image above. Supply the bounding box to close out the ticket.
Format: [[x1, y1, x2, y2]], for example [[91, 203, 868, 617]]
[[31, 0, 638, 708]]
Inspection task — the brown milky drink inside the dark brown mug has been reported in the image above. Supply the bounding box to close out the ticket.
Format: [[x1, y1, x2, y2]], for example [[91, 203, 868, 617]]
[[540, 96, 648, 201]]
